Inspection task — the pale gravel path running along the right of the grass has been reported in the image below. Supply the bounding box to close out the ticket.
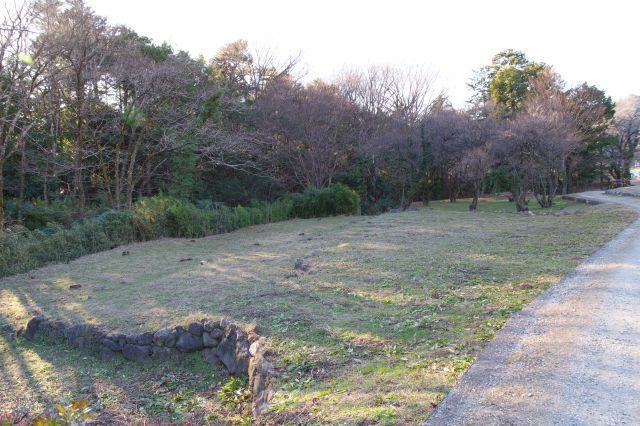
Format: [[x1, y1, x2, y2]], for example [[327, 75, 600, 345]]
[[423, 192, 640, 425]]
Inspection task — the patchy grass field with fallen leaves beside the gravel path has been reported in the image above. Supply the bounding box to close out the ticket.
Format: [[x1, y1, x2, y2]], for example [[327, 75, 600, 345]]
[[0, 200, 635, 424]]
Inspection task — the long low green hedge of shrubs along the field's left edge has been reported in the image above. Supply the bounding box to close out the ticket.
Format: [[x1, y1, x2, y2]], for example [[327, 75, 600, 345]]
[[0, 188, 359, 277]]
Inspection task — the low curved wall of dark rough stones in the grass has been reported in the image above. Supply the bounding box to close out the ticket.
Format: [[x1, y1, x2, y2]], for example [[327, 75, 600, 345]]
[[24, 315, 274, 415]]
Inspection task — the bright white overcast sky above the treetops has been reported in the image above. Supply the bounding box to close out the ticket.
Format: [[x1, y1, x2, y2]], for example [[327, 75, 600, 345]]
[[86, 0, 640, 107]]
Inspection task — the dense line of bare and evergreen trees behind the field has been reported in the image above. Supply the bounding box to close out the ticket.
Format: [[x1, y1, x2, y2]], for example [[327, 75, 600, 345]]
[[0, 0, 640, 229]]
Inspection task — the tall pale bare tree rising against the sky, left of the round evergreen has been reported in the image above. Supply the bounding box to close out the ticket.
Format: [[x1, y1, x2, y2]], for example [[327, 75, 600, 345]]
[[336, 65, 442, 208]]
